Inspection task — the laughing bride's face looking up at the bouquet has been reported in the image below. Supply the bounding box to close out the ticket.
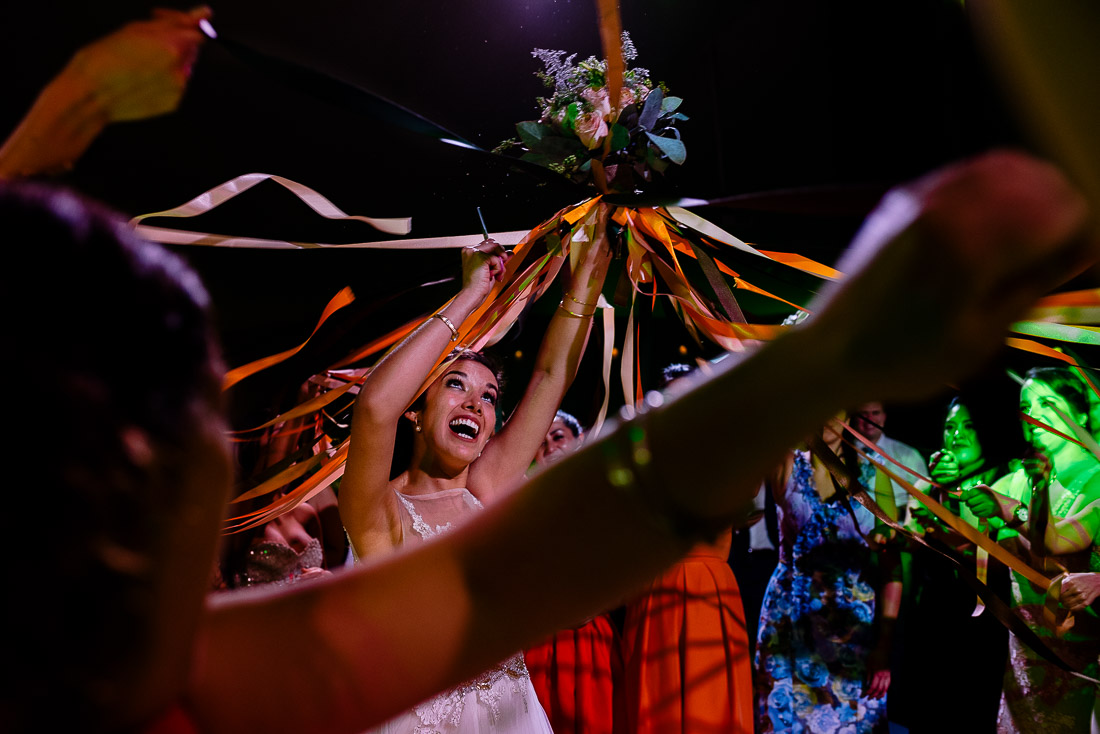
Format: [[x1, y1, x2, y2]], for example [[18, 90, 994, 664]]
[[418, 360, 499, 465]]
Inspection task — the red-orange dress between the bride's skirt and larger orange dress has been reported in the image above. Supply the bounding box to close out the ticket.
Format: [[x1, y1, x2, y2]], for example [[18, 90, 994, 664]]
[[524, 614, 623, 734]]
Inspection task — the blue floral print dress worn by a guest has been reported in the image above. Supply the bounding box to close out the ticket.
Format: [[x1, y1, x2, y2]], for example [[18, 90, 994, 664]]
[[755, 451, 887, 734]]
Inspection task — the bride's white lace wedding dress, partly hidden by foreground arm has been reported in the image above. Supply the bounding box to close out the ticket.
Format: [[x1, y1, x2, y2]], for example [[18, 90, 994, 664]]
[[372, 489, 552, 734]]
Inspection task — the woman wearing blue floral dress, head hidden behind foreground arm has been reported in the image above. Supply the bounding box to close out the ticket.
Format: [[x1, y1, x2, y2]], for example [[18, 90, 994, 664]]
[[756, 412, 902, 733]]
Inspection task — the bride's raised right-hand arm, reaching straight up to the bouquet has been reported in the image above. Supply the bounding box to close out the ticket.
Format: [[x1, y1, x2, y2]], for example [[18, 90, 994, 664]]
[[470, 204, 611, 502]]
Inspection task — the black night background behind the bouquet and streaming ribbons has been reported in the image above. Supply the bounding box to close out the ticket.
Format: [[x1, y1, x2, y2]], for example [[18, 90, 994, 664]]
[[0, 0, 1082, 449]]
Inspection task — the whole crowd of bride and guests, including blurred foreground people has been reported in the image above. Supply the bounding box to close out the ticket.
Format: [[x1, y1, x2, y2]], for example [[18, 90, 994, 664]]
[[0, 5, 1100, 734]]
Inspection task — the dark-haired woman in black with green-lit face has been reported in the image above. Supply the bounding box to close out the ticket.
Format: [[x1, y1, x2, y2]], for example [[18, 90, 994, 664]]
[[891, 376, 1022, 734]]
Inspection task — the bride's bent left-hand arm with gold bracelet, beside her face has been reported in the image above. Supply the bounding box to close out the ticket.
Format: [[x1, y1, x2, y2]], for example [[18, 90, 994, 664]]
[[340, 240, 509, 558]]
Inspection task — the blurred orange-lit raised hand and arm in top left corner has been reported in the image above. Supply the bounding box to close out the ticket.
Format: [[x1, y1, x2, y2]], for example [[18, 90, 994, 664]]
[[0, 7, 210, 179]]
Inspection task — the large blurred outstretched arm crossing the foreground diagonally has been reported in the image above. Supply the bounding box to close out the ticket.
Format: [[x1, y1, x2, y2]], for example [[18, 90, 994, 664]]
[[188, 149, 1088, 732]]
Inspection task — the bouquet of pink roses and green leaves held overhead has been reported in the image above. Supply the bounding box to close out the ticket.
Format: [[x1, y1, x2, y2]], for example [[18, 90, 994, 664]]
[[496, 32, 688, 193]]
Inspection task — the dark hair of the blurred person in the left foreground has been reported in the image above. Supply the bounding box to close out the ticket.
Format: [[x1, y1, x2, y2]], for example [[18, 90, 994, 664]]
[[0, 184, 220, 730]]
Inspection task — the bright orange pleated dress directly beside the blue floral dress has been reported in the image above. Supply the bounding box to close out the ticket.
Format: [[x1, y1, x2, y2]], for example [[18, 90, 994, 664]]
[[623, 533, 754, 734]]
